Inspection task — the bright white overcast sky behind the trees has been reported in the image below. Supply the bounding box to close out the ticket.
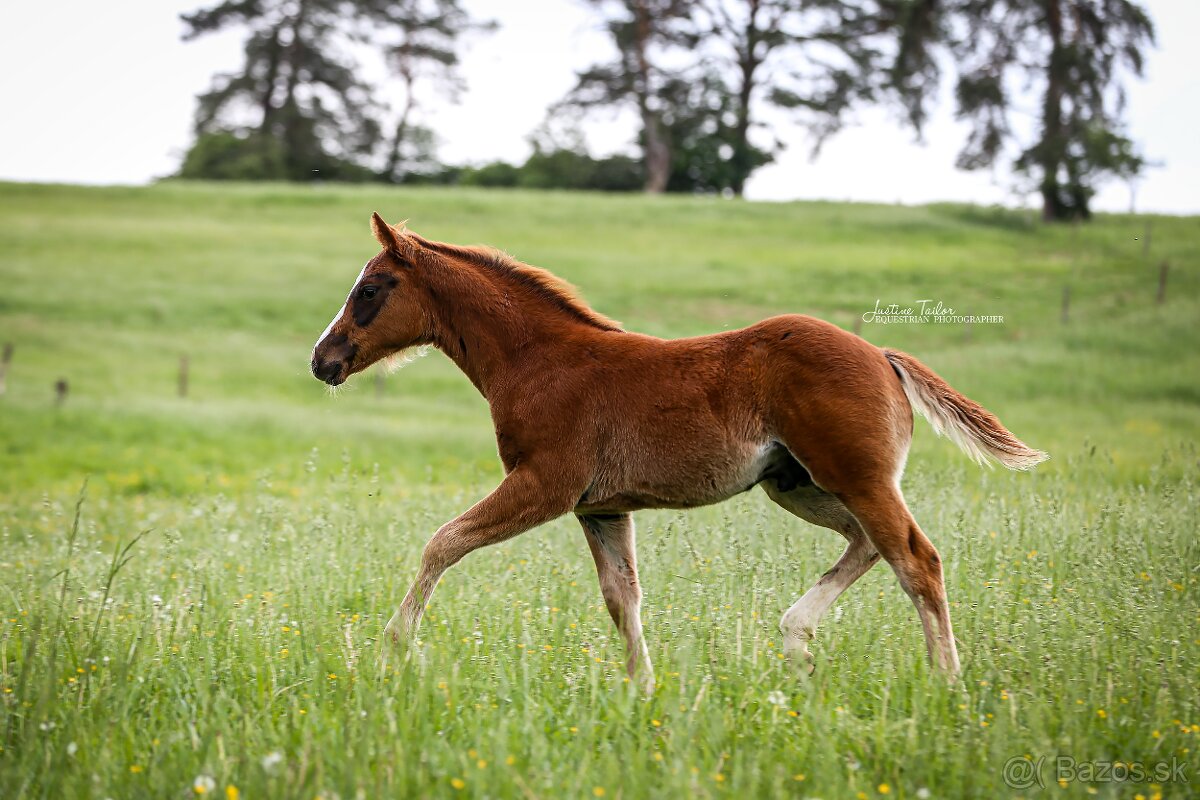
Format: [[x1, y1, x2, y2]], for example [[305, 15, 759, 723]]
[[0, 0, 1200, 213]]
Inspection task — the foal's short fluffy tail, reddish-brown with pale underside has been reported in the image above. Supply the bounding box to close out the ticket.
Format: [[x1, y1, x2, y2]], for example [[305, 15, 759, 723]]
[[883, 350, 1050, 469]]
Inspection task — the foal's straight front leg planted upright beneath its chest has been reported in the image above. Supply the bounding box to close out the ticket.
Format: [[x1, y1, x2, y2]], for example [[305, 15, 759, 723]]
[[580, 513, 654, 691]]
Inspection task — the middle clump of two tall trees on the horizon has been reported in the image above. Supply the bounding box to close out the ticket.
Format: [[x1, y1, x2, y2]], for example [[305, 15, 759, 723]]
[[568, 0, 912, 196]]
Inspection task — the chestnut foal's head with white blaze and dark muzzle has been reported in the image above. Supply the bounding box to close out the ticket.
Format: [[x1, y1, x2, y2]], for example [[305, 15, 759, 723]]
[[312, 213, 428, 386]]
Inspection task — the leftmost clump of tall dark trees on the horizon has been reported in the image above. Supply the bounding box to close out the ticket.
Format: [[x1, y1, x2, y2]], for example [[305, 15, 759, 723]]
[[181, 0, 486, 181]]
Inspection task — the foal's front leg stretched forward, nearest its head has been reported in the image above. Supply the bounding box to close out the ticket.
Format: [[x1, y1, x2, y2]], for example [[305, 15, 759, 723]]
[[384, 465, 578, 648]]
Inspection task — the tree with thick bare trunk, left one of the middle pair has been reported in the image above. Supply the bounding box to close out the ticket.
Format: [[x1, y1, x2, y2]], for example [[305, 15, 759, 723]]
[[564, 0, 696, 193]]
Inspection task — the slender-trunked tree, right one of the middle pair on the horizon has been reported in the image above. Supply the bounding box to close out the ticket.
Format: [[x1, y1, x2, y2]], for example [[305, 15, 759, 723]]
[[697, 0, 888, 196]]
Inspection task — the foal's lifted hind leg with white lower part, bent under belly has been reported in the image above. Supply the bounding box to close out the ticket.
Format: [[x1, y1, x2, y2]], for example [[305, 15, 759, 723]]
[[762, 480, 880, 674]]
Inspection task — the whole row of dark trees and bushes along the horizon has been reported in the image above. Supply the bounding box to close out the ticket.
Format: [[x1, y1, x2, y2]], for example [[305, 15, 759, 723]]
[[180, 0, 1154, 219]]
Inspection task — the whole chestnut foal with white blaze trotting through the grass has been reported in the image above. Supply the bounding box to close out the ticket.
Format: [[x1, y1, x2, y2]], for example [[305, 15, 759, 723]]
[[312, 213, 1046, 687]]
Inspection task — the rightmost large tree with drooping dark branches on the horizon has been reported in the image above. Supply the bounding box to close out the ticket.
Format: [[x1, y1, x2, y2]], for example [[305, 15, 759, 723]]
[[899, 0, 1154, 221]]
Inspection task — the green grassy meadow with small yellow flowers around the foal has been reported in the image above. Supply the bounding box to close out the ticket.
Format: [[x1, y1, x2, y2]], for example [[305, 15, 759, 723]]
[[0, 184, 1200, 800]]
